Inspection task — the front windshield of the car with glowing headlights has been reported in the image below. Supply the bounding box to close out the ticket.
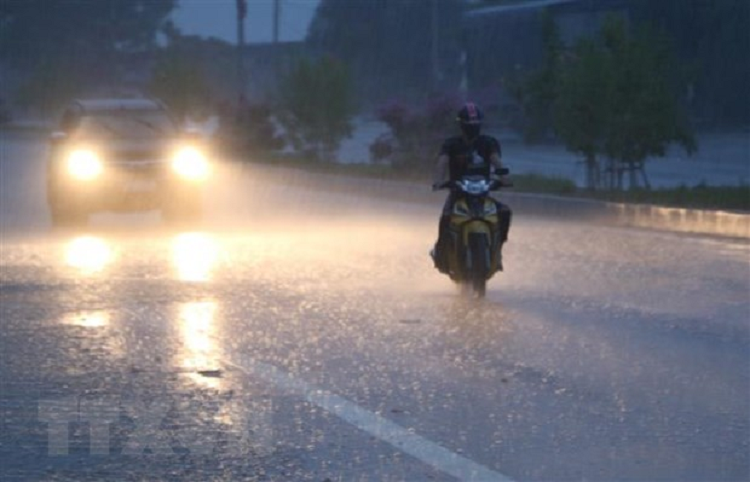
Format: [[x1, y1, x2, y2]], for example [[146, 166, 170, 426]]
[[75, 111, 177, 138]]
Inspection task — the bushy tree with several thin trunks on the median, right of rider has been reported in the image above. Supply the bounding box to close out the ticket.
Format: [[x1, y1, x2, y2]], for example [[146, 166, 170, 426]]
[[554, 16, 696, 188]]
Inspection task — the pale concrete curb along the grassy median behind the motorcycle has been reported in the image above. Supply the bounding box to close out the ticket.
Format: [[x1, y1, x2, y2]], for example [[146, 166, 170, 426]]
[[241, 165, 750, 239]]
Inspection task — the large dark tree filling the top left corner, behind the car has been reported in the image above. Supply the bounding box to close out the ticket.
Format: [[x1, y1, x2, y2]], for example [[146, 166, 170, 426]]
[[0, 0, 176, 109]]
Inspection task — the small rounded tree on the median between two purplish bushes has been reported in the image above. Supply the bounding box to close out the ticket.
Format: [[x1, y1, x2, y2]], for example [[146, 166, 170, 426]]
[[281, 57, 355, 158]]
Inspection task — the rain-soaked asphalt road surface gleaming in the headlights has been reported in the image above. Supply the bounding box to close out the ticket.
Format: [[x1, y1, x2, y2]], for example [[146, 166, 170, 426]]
[[0, 134, 750, 482]]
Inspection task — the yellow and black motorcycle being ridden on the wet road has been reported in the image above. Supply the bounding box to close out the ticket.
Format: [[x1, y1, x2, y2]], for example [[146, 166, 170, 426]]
[[435, 169, 511, 298]]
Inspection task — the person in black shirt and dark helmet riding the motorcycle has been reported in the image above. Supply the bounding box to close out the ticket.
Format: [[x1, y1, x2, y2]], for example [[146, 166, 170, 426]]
[[431, 102, 512, 273]]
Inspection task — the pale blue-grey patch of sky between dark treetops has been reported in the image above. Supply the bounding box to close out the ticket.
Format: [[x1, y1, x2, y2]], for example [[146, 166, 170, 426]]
[[172, 0, 320, 43]]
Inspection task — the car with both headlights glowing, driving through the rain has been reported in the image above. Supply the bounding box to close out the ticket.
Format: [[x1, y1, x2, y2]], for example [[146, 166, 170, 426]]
[[47, 99, 211, 226]]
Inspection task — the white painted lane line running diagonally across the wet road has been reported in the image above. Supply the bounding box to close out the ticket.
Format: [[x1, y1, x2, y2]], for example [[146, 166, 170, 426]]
[[224, 356, 512, 482]]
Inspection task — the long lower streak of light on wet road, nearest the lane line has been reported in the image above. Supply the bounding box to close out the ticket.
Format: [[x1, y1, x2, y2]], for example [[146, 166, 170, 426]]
[[178, 301, 221, 388]]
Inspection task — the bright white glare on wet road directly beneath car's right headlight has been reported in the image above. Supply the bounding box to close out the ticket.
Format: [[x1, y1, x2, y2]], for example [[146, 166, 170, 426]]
[[172, 233, 218, 282]]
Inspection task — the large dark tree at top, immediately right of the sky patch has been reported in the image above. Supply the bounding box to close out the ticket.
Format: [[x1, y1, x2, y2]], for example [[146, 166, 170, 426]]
[[307, 0, 463, 101]]
